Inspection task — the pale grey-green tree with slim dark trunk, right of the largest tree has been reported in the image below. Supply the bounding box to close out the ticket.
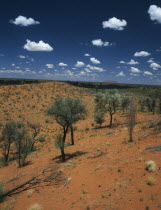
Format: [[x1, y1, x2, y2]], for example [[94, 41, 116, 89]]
[[94, 90, 121, 128]]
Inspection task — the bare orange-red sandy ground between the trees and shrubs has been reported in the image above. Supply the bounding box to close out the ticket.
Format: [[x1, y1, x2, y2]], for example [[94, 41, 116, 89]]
[[0, 82, 161, 210]]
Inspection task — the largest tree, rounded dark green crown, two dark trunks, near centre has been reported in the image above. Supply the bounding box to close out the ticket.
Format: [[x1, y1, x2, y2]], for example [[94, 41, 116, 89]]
[[47, 97, 86, 161]]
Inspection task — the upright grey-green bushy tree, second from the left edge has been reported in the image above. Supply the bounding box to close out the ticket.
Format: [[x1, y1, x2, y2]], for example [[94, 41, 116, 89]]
[[14, 122, 32, 167]]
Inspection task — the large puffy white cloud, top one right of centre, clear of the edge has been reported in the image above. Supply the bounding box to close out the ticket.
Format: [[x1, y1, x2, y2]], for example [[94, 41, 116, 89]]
[[102, 17, 127, 31]]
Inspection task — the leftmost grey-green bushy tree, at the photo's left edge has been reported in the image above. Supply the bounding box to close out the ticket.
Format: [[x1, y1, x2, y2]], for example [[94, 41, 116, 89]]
[[0, 122, 16, 165]]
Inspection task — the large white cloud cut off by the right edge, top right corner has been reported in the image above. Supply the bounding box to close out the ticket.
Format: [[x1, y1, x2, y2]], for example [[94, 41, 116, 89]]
[[148, 5, 161, 23]]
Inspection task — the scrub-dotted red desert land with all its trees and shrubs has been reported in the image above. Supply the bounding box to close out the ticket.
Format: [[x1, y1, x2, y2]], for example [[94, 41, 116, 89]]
[[0, 79, 161, 209]]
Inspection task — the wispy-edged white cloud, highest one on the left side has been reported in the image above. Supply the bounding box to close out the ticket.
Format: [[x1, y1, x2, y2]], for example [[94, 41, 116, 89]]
[[9, 15, 40, 26]]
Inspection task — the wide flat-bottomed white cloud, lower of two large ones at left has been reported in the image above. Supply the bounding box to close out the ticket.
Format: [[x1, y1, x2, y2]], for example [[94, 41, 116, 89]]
[[24, 39, 53, 51]]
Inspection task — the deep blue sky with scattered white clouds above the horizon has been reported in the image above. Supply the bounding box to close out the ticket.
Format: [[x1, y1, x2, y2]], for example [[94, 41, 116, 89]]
[[0, 0, 161, 84]]
